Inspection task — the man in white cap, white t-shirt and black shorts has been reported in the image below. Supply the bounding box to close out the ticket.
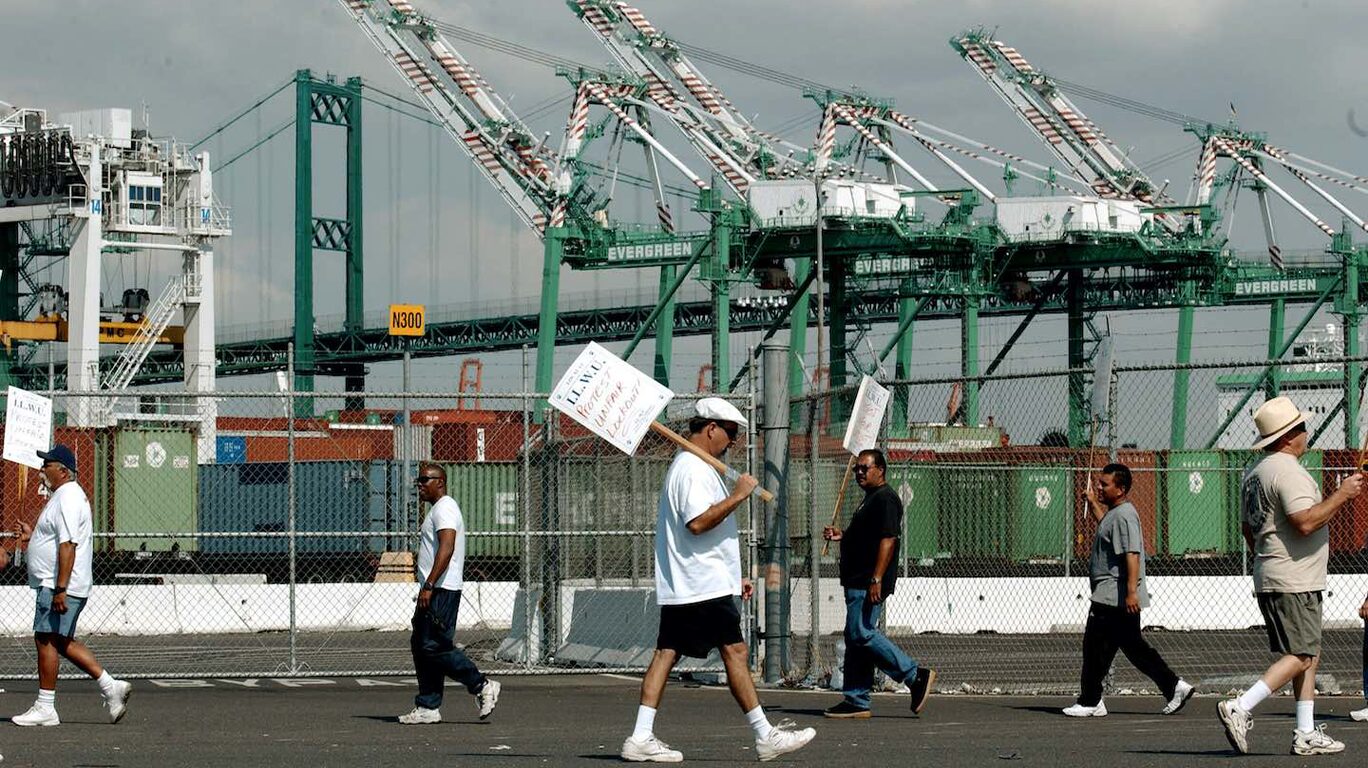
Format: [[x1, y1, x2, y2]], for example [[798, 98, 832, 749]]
[[621, 397, 817, 763]]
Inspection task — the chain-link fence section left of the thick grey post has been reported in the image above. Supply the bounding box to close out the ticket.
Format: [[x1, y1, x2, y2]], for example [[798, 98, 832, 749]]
[[0, 393, 754, 678]]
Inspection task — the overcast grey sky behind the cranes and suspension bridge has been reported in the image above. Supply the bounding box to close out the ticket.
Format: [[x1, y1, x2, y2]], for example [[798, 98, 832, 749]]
[[0, 0, 1368, 424]]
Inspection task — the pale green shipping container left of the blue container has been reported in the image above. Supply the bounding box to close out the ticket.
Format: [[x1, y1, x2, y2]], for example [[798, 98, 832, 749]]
[[109, 428, 198, 552]]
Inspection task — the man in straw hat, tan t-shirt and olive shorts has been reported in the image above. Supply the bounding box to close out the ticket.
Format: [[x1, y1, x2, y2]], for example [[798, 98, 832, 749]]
[[1216, 397, 1363, 754]]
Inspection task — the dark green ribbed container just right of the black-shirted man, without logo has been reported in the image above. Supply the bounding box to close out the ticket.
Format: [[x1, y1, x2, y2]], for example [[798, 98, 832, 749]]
[[936, 464, 1012, 559]]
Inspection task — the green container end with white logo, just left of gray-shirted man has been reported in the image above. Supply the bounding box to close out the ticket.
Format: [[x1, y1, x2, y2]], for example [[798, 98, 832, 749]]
[[1011, 467, 1074, 560]]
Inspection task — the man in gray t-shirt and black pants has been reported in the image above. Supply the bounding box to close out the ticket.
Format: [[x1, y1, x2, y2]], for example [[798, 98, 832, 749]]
[[1064, 464, 1193, 717]]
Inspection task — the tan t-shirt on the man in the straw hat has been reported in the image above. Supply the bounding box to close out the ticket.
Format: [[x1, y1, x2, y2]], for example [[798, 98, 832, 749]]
[[1239, 452, 1330, 593]]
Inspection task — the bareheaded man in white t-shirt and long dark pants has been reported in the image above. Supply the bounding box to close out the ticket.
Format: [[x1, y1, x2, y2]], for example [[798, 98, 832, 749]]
[[399, 461, 501, 726]]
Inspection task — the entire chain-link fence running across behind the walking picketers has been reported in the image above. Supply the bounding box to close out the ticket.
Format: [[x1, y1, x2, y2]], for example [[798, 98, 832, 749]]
[[0, 360, 1368, 693]]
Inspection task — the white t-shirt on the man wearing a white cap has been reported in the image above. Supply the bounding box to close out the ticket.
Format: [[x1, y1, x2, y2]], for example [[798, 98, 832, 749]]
[[655, 450, 741, 605]]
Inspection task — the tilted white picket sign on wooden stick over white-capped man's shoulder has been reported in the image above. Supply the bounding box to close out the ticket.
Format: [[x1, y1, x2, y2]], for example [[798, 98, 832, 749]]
[[547, 342, 774, 501]]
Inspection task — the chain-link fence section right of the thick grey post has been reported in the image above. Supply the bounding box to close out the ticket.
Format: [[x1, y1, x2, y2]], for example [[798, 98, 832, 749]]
[[788, 359, 1368, 693]]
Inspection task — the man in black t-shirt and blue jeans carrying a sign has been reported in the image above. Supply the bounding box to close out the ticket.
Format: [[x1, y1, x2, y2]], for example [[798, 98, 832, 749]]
[[822, 449, 936, 719]]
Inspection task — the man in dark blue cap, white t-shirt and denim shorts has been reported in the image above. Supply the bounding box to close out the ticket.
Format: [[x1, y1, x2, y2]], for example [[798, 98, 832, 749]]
[[10, 445, 133, 726]]
